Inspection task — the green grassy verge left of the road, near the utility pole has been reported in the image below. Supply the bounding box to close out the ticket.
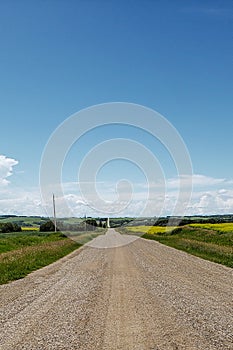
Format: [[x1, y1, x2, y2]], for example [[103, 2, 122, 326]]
[[0, 232, 80, 284]]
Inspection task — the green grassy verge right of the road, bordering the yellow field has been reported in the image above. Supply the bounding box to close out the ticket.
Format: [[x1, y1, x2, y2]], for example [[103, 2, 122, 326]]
[[122, 225, 233, 267]]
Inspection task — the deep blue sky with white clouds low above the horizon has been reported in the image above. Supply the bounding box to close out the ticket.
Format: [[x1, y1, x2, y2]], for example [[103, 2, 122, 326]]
[[0, 0, 233, 216]]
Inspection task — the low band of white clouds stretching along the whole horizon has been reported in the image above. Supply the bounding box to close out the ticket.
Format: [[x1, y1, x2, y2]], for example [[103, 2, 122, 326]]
[[0, 174, 233, 217]]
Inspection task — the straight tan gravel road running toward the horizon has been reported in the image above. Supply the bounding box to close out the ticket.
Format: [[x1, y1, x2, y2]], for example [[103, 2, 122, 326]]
[[0, 229, 233, 350]]
